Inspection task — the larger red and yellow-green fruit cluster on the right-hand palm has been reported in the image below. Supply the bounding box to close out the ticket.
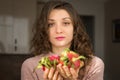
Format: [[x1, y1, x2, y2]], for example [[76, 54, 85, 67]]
[[60, 48, 85, 69]]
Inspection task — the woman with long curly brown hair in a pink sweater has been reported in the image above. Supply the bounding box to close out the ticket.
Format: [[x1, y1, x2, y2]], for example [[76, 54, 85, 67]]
[[21, 1, 104, 80]]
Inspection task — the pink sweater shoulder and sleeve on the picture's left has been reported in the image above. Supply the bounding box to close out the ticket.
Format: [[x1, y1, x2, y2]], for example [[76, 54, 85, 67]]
[[21, 54, 51, 80]]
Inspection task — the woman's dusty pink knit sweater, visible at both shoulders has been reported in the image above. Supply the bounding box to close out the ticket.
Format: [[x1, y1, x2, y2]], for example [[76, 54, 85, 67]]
[[21, 54, 104, 80]]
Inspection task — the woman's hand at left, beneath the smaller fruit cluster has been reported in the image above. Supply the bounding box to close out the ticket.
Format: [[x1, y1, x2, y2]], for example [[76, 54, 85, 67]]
[[43, 67, 63, 80]]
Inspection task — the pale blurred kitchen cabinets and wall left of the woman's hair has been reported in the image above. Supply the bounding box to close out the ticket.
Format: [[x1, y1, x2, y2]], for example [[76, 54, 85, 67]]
[[0, 0, 36, 53]]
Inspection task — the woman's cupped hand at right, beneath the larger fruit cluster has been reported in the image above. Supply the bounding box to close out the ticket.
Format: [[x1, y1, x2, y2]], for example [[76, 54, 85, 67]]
[[57, 64, 80, 80]]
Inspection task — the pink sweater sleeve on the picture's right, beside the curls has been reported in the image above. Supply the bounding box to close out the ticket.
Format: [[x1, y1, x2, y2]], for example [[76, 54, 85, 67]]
[[83, 57, 104, 80]]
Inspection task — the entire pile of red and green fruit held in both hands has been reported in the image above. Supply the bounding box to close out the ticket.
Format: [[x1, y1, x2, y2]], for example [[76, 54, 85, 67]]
[[36, 48, 86, 71]]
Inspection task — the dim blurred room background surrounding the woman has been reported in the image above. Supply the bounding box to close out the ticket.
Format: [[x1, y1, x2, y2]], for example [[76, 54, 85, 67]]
[[0, 0, 120, 80]]
